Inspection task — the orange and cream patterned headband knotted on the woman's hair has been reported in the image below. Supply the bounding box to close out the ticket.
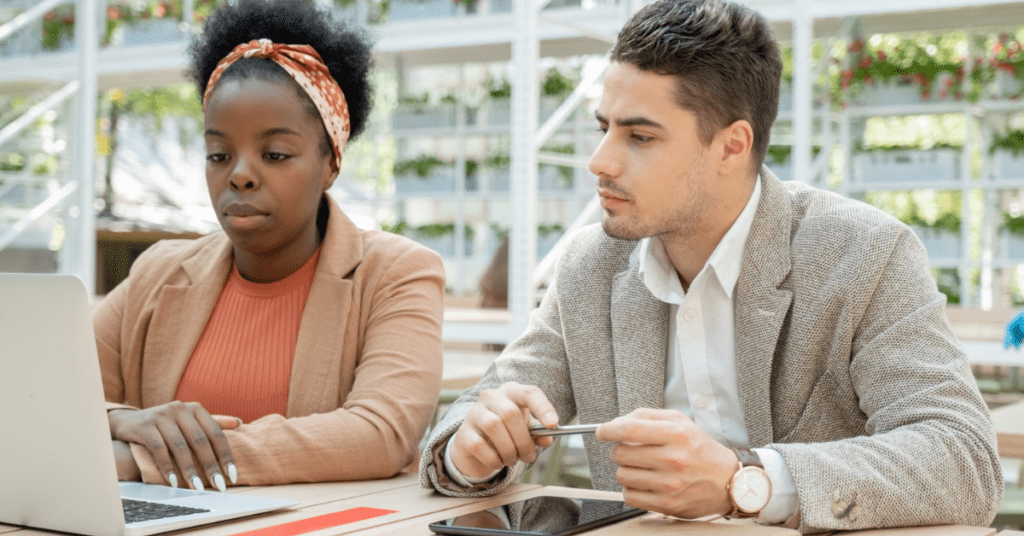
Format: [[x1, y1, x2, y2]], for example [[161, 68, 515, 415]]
[[203, 39, 350, 171]]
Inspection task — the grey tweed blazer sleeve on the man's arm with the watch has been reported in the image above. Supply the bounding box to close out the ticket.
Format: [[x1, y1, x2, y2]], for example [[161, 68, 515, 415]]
[[769, 231, 1002, 533]]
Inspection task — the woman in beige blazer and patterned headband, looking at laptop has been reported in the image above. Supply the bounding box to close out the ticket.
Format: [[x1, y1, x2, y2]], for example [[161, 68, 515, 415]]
[[93, 0, 444, 491]]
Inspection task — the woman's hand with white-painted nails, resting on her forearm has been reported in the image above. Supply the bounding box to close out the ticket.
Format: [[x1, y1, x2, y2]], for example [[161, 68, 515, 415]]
[[108, 402, 240, 491]]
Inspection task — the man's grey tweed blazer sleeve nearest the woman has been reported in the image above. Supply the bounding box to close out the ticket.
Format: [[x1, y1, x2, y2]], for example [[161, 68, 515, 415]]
[[420, 272, 575, 497]]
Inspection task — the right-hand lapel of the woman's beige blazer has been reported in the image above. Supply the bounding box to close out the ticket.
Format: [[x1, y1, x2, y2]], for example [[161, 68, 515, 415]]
[[287, 195, 364, 417]]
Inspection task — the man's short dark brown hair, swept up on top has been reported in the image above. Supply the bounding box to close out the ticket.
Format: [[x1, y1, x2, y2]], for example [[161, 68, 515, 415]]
[[611, 0, 782, 168]]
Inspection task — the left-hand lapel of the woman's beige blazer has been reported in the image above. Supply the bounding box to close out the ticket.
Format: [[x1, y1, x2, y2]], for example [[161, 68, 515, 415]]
[[141, 234, 231, 407]]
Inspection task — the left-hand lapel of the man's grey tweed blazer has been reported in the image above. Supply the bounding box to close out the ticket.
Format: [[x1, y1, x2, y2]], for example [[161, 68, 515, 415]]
[[611, 247, 669, 415]]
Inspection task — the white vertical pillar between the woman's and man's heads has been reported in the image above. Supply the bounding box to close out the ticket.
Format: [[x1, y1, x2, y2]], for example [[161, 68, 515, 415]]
[[509, 0, 540, 339]]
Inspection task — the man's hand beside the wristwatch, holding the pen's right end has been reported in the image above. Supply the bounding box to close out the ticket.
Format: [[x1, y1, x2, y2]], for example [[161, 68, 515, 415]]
[[596, 409, 739, 519]]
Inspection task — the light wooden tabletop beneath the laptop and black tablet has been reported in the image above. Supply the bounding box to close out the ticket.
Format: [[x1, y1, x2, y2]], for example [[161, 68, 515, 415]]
[[0, 473, 995, 536]]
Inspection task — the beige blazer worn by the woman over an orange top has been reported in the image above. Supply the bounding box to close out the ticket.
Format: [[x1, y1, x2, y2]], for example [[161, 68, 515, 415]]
[[93, 198, 444, 485]]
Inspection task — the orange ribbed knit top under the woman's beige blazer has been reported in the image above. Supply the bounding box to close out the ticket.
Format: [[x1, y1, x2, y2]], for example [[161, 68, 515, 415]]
[[176, 249, 319, 422]]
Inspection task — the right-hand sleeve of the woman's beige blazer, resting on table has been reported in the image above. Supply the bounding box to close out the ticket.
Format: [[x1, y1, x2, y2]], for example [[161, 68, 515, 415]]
[[193, 247, 444, 485]]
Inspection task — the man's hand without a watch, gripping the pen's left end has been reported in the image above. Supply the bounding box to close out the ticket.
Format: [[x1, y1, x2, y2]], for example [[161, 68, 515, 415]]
[[451, 381, 558, 479]]
